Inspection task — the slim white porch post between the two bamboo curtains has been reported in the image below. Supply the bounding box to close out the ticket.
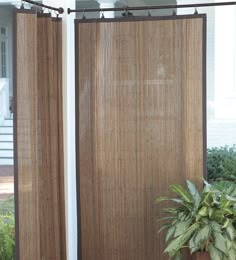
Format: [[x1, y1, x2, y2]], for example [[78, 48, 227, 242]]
[[43, 0, 77, 260]]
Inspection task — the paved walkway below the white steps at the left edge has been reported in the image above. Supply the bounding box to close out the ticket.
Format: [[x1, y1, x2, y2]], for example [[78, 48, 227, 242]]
[[0, 166, 14, 201]]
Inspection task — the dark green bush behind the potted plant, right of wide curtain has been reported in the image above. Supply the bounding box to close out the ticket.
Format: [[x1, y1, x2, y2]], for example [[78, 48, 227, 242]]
[[207, 145, 236, 183]]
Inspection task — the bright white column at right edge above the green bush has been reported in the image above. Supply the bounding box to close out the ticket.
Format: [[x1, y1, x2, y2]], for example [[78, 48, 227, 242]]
[[215, 3, 236, 120]]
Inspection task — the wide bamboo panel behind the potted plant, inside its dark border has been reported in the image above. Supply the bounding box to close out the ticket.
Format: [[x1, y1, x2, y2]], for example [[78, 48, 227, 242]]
[[76, 16, 205, 260]]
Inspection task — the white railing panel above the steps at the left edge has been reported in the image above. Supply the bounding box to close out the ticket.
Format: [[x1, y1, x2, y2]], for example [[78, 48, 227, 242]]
[[0, 78, 10, 124]]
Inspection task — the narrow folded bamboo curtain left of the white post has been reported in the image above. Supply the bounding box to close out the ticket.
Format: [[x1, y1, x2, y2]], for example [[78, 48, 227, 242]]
[[14, 11, 66, 260]]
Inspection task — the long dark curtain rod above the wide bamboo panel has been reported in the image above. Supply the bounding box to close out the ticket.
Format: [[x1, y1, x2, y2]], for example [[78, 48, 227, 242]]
[[67, 1, 236, 14]]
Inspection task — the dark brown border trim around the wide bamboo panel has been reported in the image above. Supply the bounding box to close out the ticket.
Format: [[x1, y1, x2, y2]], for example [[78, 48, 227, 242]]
[[75, 14, 207, 260]]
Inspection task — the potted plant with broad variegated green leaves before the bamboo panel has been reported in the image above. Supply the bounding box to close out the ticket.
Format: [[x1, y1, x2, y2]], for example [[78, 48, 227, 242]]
[[156, 180, 236, 260]]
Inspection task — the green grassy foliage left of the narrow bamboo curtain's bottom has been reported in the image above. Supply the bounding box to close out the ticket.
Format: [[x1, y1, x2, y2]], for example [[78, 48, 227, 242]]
[[0, 197, 15, 260]]
